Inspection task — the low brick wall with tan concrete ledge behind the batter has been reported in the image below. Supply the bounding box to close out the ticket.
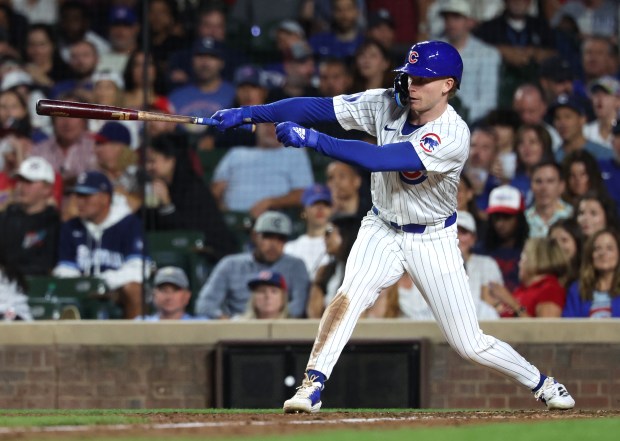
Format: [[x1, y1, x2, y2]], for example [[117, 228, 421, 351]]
[[0, 319, 620, 408]]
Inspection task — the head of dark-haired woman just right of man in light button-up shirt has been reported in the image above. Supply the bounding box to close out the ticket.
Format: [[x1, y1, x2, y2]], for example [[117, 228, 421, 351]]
[[562, 150, 606, 205]]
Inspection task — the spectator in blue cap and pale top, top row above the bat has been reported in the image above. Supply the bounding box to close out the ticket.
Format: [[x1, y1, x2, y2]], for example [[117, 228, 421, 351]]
[[97, 5, 140, 75]]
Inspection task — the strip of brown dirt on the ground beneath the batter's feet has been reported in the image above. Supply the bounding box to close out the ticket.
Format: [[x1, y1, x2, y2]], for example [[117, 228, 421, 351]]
[[0, 409, 620, 440]]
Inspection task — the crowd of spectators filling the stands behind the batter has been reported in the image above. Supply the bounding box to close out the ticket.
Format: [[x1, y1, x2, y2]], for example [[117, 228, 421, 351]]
[[0, 0, 620, 321]]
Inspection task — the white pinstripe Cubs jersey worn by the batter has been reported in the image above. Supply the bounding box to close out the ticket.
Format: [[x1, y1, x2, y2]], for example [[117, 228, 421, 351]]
[[334, 89, 469, 225]]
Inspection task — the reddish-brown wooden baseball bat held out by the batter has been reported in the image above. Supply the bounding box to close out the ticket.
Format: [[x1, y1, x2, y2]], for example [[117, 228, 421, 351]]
[[37, 100, 256, 131]]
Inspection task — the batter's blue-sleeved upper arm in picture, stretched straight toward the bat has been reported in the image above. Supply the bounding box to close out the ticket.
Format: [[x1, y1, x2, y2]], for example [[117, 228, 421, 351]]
[[249, 97, 337, 125]]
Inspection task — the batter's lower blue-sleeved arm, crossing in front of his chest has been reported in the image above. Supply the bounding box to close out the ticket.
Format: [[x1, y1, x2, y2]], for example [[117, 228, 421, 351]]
[[315, 133, 425, 172]]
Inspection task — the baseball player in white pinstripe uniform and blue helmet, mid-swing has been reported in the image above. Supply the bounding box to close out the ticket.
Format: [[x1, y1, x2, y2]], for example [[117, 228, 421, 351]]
[[213, 41, 575, 413]]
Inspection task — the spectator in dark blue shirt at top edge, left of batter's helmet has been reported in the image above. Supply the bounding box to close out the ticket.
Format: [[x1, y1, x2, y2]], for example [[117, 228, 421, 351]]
[[309, 0, 364, 59]]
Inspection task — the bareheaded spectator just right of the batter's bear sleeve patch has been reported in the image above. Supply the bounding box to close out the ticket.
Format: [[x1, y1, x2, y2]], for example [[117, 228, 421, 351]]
[[463, 125, 501, 210]]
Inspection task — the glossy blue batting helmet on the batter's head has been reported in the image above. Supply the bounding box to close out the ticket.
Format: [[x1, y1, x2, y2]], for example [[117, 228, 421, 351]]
[[394, 41, 463, 87]]
